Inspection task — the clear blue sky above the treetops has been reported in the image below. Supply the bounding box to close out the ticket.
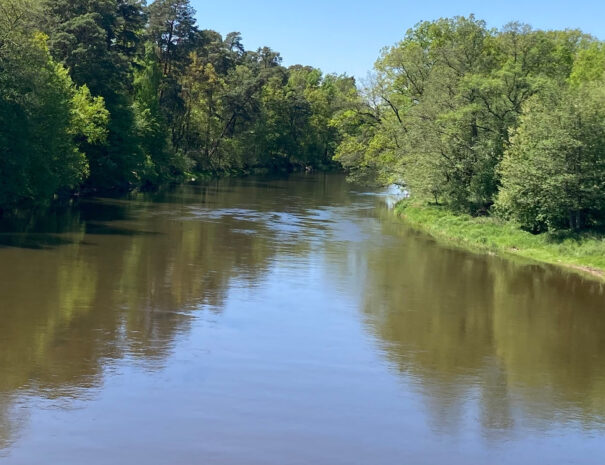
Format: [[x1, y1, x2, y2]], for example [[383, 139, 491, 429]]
[[192, 0, 605, 77]]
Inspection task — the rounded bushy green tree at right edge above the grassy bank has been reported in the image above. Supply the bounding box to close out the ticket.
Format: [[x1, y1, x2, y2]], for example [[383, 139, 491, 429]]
[[497, 83, 605, 232]]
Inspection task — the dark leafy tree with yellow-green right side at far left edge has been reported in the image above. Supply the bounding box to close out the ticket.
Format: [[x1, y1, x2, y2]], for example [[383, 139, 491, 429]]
[[0, 0, 108, 208]]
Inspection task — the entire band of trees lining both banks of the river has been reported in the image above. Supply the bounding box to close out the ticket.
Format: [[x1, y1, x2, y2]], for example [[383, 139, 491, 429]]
[[0, 5, 605, 232]]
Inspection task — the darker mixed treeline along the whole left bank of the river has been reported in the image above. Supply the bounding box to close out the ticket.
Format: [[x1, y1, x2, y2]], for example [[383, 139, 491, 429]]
[[0, 0, 356, 208]]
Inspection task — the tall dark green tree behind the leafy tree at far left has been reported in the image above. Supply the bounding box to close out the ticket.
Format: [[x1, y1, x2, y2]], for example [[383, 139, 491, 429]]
[[45, 0, 144, 188]]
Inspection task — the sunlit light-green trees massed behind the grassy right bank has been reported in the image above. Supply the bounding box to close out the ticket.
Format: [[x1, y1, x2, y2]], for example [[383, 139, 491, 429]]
[[334, 16, 605, 232]]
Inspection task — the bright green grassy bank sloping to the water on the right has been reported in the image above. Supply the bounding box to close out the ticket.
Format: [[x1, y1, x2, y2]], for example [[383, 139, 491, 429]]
[[396, 200, 605, 279]]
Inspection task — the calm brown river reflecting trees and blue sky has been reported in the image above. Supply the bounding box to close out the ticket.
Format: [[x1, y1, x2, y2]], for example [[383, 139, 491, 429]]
[[0, 175, 605, 465]]
